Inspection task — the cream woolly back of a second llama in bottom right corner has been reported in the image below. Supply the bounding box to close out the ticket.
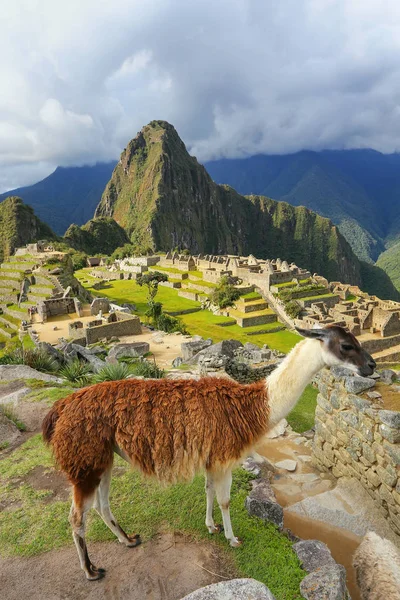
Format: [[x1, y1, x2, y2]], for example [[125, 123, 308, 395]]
[[353, 531, 400, 600]]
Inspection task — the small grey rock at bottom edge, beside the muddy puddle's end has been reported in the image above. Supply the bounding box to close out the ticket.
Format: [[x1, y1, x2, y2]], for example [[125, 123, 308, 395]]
[[300, 565, 348, 600]]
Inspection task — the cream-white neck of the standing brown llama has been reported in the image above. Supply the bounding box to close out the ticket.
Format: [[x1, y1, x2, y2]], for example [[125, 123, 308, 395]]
[[266, 339, 325, 426]]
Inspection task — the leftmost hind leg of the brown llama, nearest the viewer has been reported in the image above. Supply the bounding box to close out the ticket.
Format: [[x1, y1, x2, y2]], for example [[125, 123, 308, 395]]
[[69, 476, 105, 581]]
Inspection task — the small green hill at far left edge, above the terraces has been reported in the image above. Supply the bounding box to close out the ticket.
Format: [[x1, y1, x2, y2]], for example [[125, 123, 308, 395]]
[[0, 196, 57, 262]]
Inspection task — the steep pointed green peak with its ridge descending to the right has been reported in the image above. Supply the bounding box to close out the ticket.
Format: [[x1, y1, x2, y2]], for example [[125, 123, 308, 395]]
[[95, 121, 397, 297]]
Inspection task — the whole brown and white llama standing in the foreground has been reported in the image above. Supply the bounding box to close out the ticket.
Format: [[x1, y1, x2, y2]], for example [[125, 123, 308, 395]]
[[43, 326, 376, 580]]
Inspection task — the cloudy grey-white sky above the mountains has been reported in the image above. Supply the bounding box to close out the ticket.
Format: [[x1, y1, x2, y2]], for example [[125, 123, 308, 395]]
[[0, 0, 400, 191]]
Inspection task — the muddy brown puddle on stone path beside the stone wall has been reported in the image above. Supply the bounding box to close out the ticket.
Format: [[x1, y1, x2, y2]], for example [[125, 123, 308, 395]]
[[257, 436, 362, 600]]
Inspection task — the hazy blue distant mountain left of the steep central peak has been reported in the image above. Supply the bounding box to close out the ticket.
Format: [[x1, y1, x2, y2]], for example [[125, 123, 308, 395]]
[[0, 162, 115, 235]]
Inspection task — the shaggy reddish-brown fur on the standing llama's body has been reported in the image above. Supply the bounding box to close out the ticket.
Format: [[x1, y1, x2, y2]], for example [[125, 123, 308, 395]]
[[43, 377, 269, 485]]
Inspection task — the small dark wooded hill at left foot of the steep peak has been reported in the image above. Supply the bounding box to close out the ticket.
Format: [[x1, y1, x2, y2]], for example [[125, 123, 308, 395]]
[[64, 217, 129, 254]]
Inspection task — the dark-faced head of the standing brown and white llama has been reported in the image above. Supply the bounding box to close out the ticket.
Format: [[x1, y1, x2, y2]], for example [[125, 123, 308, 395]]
[[296, 325, 376, 377]]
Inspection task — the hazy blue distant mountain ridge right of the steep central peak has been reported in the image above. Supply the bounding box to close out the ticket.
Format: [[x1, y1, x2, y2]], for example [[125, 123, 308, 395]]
[[205, 150, 400, 262]]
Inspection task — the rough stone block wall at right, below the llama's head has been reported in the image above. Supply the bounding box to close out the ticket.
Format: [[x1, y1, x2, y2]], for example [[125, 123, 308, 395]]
[[313, 367, 400, 535]]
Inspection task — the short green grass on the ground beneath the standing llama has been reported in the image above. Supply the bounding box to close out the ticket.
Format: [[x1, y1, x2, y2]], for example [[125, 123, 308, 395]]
[[0, 436, 305, 600]]
